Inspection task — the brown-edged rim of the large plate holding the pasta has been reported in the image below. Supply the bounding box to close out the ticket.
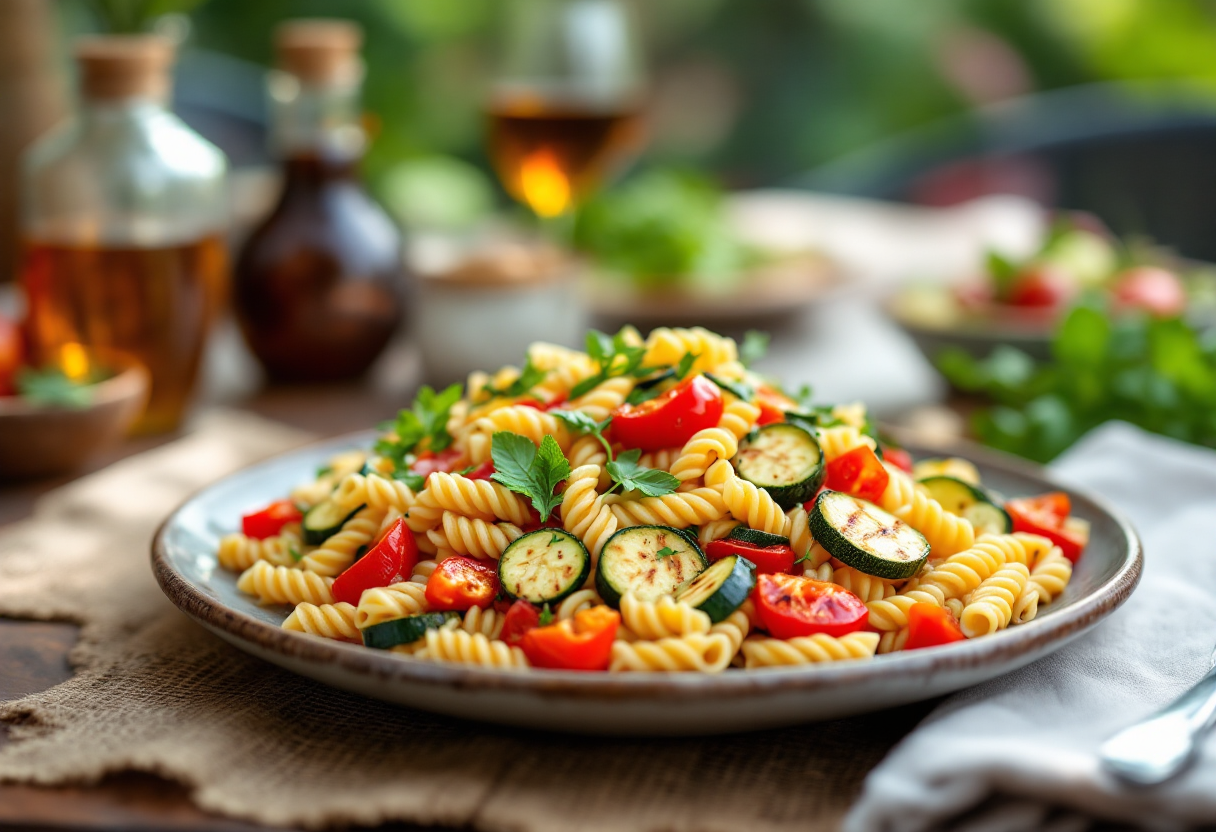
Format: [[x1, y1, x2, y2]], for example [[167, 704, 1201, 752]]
[[151, 431, 1144, 703]]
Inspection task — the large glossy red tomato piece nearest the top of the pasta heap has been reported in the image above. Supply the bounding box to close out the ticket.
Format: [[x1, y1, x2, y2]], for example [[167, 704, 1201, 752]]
[[612, 376, 722, 451]]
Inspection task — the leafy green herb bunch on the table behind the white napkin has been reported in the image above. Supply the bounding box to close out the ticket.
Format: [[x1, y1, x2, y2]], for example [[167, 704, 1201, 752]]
[[938, 307, 1216, 462]]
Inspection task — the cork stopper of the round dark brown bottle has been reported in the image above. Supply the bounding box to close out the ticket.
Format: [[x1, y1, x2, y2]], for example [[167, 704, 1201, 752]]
[[275, 18, 364, 86]]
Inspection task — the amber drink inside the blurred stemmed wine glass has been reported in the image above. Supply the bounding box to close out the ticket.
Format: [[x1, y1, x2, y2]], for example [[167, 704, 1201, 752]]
[[489, 96, 642, 217]]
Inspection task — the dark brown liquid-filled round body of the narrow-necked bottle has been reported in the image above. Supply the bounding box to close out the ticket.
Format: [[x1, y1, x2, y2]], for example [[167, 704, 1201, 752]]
[[233, 154, 405, 382]]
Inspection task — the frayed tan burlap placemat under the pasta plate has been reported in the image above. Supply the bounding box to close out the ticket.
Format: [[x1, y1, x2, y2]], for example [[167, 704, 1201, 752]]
[[0, 414, 923, 832]]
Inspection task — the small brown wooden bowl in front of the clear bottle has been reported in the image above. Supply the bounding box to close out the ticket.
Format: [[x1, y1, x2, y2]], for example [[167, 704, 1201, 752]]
[[0, 362, 150, 479]]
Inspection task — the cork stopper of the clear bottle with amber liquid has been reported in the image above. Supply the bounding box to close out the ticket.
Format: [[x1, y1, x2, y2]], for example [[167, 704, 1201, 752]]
[[74, 35, 174, 100]]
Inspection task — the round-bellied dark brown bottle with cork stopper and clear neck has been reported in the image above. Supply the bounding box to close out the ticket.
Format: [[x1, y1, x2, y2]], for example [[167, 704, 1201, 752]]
[[233, 19, 409, 382]]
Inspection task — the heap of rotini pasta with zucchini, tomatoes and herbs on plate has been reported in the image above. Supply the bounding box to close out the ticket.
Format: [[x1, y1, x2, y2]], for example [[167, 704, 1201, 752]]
[[218, 327, 1088, 673]]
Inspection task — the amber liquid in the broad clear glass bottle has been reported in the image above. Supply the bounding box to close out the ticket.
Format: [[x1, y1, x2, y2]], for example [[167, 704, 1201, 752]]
[[22, 235, 227, 433]]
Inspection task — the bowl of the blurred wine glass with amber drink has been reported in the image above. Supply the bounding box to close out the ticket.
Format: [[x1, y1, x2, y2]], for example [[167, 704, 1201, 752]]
[[488, 0, 646, 219]]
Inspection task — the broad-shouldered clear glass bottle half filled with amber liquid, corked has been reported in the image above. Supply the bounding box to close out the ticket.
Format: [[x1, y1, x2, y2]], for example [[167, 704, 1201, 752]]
[[21, 36, 227, 433]]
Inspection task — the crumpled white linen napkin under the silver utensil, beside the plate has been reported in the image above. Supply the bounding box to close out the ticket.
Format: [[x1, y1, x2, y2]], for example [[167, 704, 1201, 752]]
[[845, 423, 1216, 832]]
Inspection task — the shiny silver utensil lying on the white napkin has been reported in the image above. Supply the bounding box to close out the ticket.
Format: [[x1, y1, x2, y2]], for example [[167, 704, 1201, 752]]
[[1098, 653, 1216, 786]]
